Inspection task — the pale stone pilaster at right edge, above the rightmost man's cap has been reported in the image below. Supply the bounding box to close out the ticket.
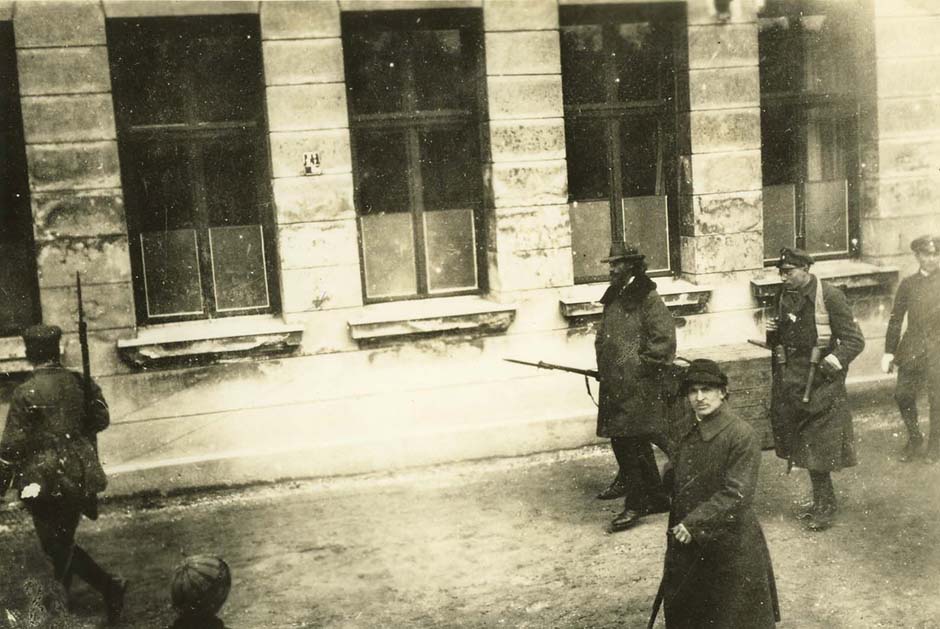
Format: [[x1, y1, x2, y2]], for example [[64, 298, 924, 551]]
[[861, 0, 940, 263]]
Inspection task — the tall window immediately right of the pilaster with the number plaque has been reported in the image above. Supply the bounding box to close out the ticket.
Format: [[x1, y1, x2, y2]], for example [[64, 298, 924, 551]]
[[342, 10, 485, 301]]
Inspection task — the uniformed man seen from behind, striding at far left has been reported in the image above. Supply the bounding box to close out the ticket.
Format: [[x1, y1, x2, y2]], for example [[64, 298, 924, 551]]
[[0, 325, 127, 623]]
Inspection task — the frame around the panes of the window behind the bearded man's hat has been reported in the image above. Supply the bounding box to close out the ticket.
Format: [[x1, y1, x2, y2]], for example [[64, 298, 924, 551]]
[[559, 2, 686, 284]]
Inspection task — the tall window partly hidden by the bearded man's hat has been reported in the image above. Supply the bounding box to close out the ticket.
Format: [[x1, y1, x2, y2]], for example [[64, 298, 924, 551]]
[[560, 4, 684, 282]]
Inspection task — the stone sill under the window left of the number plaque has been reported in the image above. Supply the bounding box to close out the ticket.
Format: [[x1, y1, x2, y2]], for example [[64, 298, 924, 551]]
[[117, 315, 304, 369]]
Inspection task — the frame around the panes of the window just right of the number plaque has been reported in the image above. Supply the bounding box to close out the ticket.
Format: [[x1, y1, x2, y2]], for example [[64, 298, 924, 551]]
[[340, 8, 488, 304]]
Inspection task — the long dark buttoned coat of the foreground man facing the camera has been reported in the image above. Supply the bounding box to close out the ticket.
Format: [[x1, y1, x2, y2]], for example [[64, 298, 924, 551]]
[[662, 406, 779, 629]]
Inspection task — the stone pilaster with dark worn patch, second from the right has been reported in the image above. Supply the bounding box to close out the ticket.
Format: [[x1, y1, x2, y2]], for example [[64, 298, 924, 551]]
[[679, 1, 763, 282]]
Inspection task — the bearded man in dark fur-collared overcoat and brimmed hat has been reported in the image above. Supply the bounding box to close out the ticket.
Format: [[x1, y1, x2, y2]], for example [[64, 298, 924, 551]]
[[594, 242, 676, 531]]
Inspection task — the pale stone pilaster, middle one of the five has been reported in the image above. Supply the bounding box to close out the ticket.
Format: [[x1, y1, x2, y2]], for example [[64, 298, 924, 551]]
[[483, 0, 573, 297]]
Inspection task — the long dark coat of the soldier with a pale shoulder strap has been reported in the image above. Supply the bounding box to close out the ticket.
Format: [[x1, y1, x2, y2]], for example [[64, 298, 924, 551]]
[[769, 277, 865, 472]]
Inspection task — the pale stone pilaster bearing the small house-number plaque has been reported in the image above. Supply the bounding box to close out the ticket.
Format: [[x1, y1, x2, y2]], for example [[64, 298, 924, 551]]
[[261, 0, 362, 314]]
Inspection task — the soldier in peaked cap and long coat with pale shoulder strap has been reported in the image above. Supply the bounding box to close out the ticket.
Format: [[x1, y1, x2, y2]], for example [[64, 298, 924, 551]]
[[767, 248, 865, 531]]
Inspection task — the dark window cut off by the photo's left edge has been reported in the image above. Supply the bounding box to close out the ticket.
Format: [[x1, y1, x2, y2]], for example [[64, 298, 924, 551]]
[[0, 22, 41, 336]]
